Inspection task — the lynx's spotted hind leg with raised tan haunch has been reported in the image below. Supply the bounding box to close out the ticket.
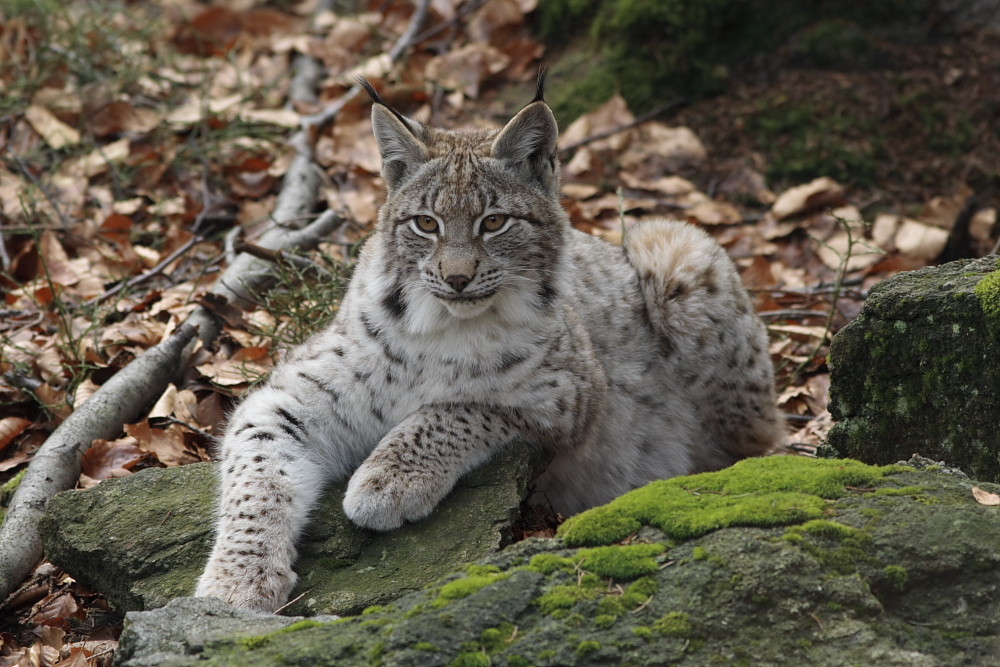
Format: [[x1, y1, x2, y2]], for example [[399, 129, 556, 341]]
[[624, 220, 784, 470]]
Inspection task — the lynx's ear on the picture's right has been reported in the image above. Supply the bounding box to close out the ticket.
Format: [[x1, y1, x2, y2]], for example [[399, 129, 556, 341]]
[[491, 100, 559, 193]]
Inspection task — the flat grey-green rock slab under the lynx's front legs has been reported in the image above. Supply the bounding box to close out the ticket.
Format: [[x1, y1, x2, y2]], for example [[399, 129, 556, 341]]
[[41, 447, 539, 615]]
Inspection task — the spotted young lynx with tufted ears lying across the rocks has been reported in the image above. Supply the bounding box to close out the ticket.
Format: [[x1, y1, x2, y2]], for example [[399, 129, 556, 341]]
[[197, 77, 781, 610]]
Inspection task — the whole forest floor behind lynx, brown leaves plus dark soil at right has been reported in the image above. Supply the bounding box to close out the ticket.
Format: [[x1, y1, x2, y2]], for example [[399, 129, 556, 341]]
[[0, 0, 1000, 666]]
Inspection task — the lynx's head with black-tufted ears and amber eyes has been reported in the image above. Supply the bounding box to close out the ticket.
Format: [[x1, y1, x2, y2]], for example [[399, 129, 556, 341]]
[[365, 78, 569, 330]]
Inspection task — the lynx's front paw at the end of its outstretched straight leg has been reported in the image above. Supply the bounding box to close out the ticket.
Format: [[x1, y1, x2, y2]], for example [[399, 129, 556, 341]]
[[195, 562, 296, 612]]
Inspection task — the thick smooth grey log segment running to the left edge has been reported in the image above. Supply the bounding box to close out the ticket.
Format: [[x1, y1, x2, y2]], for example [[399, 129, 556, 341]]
[[0, 326, 195, 599]]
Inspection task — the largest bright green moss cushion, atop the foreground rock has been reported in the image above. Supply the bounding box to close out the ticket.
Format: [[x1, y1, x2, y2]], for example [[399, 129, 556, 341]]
[[559, 456, 899, 546]]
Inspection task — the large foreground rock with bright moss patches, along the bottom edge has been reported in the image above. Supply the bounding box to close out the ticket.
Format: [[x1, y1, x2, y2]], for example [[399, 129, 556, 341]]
[[115, 456, 1000, 667]]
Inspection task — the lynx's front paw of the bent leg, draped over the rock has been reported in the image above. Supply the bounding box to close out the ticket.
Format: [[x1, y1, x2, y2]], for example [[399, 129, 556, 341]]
[[344, 463, 447, 530]]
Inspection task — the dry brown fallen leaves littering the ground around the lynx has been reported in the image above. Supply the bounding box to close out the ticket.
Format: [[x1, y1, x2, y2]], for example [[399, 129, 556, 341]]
[[0, 0, 997, 656]]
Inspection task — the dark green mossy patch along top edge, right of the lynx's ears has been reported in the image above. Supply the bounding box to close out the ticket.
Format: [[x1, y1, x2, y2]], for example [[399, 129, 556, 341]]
[[537, 0, 932, 124]]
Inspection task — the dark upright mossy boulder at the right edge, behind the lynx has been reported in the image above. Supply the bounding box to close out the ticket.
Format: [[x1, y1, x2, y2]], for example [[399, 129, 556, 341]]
[[829, 257, 1000, 481]]
